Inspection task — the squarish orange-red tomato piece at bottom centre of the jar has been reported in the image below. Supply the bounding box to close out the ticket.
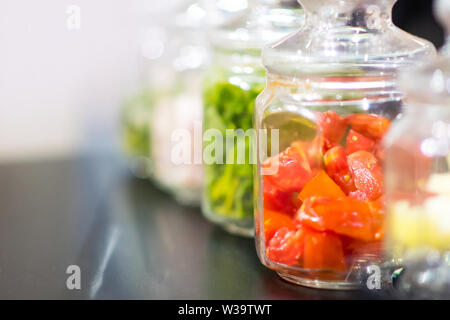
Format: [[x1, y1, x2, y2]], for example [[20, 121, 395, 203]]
[[303, 230, 347, 271]]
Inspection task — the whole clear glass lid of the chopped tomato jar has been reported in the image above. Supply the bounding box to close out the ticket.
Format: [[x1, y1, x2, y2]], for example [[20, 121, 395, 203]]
[[263, 0, 435, 74]]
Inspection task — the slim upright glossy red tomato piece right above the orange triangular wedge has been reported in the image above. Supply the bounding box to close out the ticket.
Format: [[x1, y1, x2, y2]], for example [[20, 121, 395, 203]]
[[324, 146, 356, 194]]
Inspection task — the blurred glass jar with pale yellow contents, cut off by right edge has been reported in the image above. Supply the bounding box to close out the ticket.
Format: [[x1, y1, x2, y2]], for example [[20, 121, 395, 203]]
[[385, 0, 450, 299]]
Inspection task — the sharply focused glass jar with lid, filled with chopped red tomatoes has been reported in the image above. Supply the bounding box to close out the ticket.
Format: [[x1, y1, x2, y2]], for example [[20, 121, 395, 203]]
[[255, 0, 435, 289]]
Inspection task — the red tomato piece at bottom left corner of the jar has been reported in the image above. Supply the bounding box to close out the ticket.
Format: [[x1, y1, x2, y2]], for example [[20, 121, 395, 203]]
[[266, 227, 304, 266]]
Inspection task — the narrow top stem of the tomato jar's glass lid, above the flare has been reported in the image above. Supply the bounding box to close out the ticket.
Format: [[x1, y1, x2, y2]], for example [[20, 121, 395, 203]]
[[299, 0, 397, 30]]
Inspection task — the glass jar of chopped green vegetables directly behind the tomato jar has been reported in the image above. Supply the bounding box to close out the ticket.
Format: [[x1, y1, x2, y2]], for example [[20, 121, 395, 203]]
[[202, 0, 303, 236]]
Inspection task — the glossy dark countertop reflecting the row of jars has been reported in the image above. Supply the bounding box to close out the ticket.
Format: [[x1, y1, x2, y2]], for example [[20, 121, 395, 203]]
[[0, 156, 374, 299]]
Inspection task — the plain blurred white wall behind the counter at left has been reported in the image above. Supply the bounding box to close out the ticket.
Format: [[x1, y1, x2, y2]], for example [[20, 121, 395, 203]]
[[0, 0, 183, 163]]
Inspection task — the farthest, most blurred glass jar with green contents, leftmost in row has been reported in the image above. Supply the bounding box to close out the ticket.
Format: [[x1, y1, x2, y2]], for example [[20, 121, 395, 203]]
[[120, 0, 186, 179]]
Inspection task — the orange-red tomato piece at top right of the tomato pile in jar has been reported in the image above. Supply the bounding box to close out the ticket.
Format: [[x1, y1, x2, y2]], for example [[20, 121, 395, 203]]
[[346, 114, 391, 139]]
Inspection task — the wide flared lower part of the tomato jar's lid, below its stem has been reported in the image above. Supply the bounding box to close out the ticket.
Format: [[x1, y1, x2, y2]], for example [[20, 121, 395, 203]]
[[262, 24, 436, 75]]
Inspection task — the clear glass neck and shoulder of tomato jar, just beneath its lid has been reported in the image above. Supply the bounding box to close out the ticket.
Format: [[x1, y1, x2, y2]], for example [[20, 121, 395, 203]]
[[256, 71, 403, 122]]
